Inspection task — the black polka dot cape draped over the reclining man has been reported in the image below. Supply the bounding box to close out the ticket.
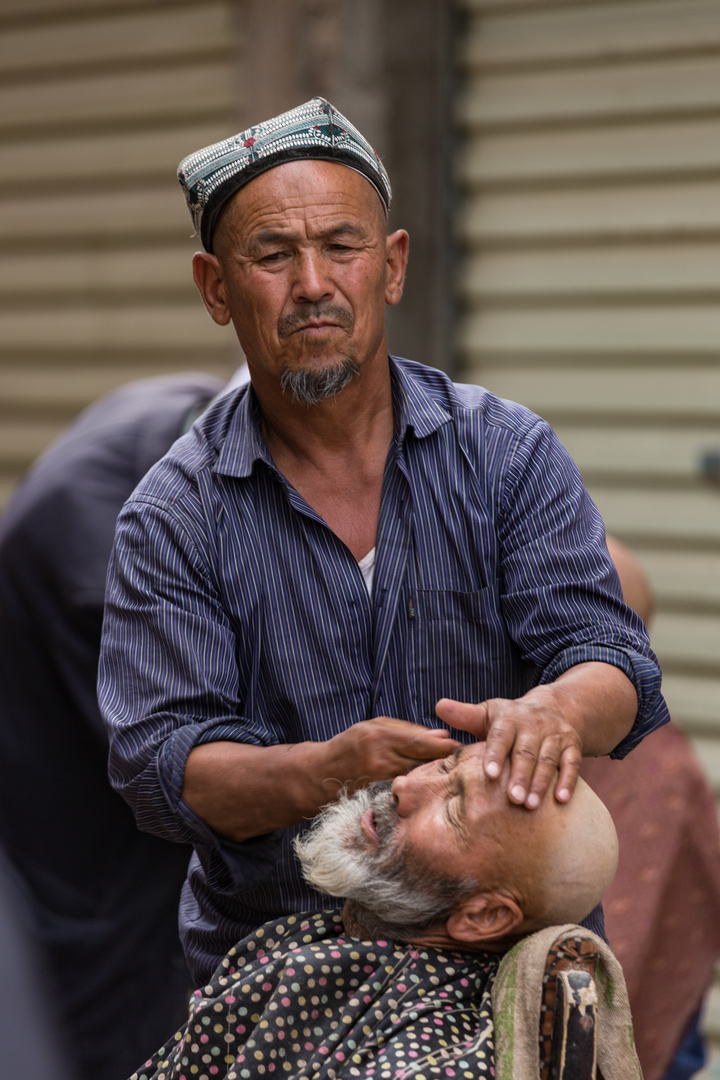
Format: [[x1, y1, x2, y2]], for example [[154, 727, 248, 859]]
[[132, 910, 499, 1080]]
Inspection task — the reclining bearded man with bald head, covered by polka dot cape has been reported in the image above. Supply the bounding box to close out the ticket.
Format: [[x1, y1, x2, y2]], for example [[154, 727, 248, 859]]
[[136, 743, 631, 1080]]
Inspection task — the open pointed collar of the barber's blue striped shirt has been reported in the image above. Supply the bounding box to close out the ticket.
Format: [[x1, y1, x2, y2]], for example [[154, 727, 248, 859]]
[[215, 356, 451, 476]]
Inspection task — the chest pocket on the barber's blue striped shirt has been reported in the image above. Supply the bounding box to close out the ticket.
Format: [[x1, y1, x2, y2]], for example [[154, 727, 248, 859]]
[[408, 582, 515, 724]]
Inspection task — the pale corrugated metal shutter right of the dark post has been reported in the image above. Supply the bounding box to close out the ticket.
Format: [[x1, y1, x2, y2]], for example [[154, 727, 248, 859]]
[[457, 0, 720, 1054]]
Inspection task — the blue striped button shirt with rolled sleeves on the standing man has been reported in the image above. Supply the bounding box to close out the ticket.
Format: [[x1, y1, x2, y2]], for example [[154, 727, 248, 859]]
[[99, 360, 667, 982]]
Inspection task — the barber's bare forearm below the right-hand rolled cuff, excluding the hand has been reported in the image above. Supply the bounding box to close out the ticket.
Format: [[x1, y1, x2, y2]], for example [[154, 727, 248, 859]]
[[526, 661, 638, 757]]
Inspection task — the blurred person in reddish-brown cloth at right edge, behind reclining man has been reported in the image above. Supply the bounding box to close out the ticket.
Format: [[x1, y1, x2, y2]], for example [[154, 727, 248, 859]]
[[582, 537, 720, 1080]]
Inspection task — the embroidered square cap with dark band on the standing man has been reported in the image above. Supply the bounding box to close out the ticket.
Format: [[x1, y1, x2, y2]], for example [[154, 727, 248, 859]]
[[177, 97, 392, 252]]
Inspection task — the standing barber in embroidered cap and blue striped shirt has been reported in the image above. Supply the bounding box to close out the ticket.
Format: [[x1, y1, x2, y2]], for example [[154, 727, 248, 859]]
[[99, 98, 667, 983]]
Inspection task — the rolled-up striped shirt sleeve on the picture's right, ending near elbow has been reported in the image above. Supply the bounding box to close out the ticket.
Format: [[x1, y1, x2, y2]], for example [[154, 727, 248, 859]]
[[499, 412, 669, 757]]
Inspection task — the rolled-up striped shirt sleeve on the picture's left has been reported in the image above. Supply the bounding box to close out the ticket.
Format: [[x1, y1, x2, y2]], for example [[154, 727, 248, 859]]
[[98, 496, 270, 849]]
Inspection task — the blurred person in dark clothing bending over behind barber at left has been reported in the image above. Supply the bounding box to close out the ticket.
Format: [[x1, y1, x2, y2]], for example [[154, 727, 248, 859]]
[[0, 374, 246, 1080]]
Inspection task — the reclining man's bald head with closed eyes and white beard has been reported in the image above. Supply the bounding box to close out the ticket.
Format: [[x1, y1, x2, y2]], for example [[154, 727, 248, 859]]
[[298, 743, 617, 949]]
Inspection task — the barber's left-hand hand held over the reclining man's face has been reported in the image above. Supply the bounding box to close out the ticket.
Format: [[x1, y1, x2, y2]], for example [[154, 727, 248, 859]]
[[326, 716, 460, 791]]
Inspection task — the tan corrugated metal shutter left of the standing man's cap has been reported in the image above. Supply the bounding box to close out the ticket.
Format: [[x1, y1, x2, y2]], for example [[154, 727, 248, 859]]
[[0, 0, 239, 503]]
